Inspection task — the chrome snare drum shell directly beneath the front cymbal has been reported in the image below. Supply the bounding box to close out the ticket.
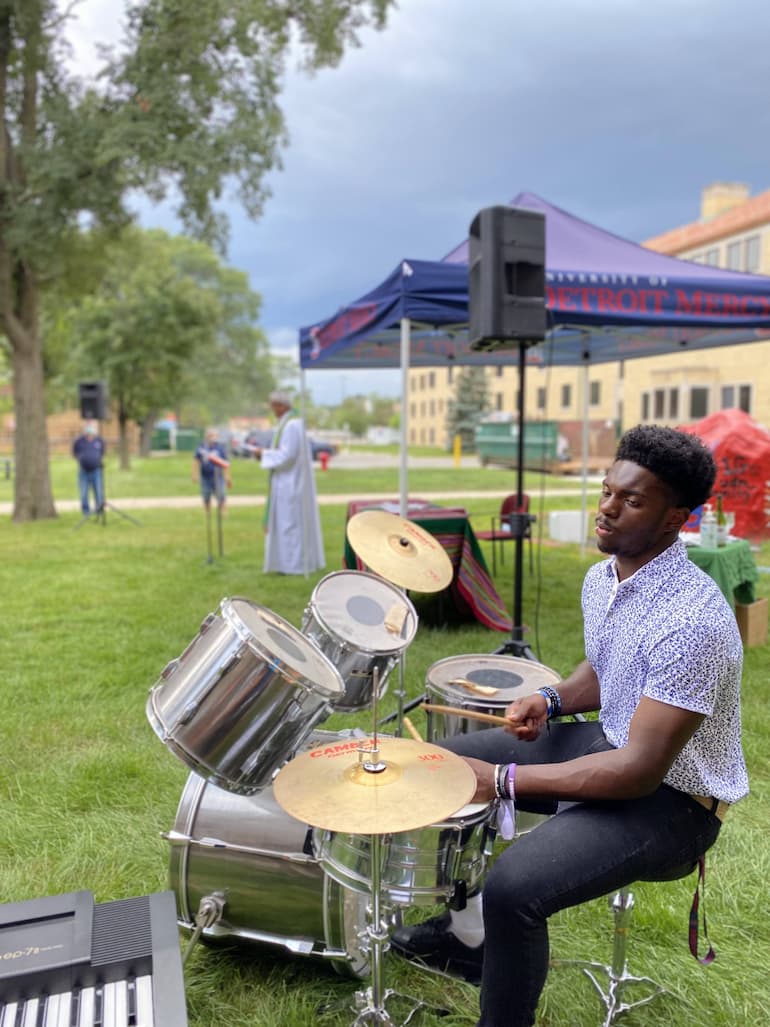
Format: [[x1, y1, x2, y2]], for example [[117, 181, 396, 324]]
[[313, 802, 495, 909]]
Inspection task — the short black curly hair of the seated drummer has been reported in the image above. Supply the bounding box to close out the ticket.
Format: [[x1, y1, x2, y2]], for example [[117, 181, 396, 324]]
[[615, 424, 717, 510]]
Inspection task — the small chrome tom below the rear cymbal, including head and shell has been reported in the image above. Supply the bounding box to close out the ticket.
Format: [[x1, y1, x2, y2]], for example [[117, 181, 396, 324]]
[[302, 571, 418, 713]]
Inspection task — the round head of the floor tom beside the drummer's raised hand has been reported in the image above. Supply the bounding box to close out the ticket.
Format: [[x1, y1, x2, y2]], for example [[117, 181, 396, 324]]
[[427, 654, 561, 708]]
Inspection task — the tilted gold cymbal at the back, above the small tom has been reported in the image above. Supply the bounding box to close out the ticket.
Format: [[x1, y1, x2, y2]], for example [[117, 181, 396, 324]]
[[347, 510, 454, 593]]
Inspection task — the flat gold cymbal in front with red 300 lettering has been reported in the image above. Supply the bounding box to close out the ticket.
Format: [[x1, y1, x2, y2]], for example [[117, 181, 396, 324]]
[[273, 736, 475, 835]]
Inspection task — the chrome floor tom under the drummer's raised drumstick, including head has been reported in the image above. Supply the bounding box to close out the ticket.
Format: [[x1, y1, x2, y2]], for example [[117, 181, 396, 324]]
[[425, 654, 561, 741]]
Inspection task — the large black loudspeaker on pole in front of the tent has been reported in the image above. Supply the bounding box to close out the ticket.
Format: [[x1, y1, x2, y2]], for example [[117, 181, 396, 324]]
[[468, 206, 546, 352]]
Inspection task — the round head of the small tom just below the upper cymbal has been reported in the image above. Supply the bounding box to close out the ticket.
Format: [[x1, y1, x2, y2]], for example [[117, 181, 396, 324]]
[[310, 571, 417, 652]]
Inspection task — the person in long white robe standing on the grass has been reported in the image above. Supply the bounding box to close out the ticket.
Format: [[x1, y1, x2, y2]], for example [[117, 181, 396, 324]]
[[254, 391, 325, 574]]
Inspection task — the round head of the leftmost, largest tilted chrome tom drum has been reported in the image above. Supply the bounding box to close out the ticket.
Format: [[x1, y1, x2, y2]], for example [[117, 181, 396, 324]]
[[222, 599, 345, 697]]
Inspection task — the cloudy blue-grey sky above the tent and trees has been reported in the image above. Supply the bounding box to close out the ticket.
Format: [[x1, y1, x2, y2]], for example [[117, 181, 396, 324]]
[[73, 0, 770, 403]]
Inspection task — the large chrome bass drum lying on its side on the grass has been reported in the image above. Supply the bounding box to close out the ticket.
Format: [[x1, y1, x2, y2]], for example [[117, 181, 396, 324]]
[[164, 731, 370, 978]]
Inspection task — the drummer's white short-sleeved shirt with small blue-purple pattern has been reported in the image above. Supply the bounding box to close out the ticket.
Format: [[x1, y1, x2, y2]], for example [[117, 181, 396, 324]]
[[582, 540, 748, 802]]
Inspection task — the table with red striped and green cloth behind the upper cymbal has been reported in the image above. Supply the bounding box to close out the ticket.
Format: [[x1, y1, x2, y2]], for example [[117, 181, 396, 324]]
[[343, 499, 512, 632]]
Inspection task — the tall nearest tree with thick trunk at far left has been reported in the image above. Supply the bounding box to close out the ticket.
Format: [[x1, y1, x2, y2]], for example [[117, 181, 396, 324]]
[[0, 0, 392, 521]]
